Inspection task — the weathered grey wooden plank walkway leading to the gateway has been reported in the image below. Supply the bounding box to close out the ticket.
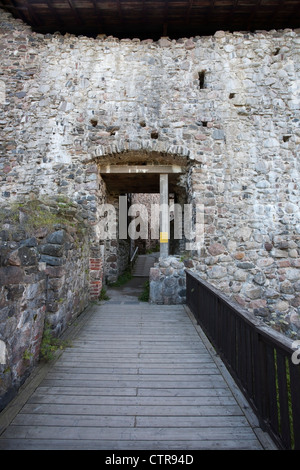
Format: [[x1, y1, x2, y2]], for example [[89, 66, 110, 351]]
[[0, 301, 276, 450]]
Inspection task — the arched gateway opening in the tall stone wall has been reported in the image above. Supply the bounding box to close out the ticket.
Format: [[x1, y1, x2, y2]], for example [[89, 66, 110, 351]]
[[97, 151, 189, 283]]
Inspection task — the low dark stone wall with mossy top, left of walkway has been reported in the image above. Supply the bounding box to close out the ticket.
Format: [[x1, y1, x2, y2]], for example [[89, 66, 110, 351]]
[[0, 201, 89, 409]]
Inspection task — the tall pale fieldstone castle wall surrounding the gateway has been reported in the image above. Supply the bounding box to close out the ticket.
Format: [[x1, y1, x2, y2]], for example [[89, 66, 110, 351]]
[[0, 8, 300, 342]]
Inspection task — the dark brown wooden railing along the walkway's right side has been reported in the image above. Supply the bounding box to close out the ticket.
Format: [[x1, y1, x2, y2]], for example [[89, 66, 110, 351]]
[[186, 270, 300, 450]]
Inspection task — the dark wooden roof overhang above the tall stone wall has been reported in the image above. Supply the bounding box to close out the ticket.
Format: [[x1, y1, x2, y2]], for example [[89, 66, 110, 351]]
[[0, 0, 300, 39]]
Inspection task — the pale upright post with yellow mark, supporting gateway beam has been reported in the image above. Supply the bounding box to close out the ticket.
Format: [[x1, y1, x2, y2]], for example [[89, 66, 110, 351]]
[[159, 174, 170, 258]]
